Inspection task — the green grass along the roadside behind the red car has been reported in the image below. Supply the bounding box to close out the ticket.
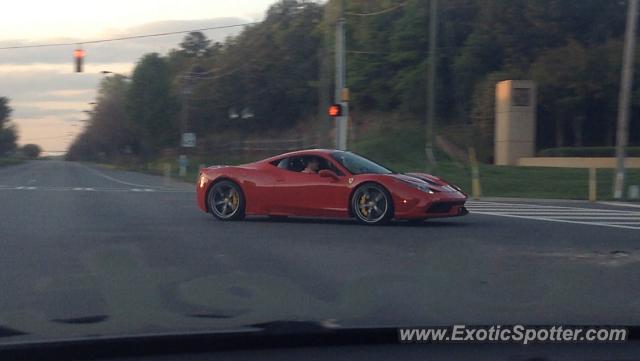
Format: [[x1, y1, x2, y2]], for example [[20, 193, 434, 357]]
[[94, 123, 640, 200]]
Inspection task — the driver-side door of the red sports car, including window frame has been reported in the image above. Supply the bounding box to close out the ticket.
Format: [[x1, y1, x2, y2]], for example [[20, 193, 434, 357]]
[[273, 156, 349, 217]]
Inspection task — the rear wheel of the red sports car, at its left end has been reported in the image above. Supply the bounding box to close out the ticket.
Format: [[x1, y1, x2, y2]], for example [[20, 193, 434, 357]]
[[208, 180, 245, 221]]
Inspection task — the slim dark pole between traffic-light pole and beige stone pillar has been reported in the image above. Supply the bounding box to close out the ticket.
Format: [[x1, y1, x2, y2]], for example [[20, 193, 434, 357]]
[[424, 0, 438, 169]]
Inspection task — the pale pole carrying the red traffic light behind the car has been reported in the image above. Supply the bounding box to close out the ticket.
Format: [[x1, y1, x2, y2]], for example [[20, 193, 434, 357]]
[[335, 0, 349, 150]]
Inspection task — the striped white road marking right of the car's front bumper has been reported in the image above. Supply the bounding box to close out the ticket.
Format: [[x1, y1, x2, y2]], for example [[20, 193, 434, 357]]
[[467, 201, 640, 229]]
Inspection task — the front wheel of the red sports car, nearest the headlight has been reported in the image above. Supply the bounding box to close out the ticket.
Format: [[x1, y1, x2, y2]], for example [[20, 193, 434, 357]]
[[351, 183, 393, 224]]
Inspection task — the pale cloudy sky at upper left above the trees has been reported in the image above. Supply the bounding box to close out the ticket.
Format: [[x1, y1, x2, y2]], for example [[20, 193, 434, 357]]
[[0, 0, 277, 153]]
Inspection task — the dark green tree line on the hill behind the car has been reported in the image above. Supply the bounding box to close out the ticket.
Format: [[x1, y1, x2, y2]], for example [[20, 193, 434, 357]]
[[69, 0, 640, 159]]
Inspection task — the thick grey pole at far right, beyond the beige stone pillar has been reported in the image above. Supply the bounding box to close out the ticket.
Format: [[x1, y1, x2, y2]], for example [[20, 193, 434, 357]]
[[613, 0, 638, 199]]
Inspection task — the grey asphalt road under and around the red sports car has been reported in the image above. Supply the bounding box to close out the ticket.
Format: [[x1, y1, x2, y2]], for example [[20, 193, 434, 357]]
[[0, 161, 640, 343]]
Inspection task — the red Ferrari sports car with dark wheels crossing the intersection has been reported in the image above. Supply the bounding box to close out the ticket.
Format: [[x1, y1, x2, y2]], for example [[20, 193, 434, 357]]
[[196, 149, 468, 224]]
